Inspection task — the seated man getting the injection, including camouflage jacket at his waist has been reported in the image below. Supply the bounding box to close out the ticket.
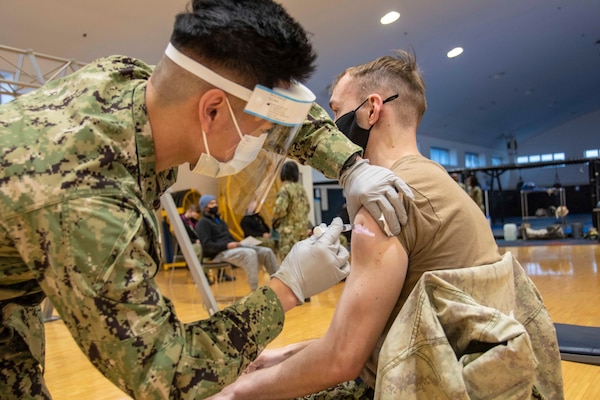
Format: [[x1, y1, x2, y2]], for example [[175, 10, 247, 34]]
[[209, 51, 562, 400]]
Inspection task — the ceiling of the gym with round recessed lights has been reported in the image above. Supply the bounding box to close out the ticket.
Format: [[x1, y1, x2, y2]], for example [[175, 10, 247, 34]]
[[0, 0, 600, 147]]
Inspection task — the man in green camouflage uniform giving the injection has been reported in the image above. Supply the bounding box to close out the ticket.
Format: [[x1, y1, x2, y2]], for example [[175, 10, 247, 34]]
[[0, 0, 412, 399]]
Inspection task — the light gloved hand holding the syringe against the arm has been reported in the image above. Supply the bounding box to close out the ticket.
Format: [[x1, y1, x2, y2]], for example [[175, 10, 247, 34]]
[[273, 218, 350, 304]]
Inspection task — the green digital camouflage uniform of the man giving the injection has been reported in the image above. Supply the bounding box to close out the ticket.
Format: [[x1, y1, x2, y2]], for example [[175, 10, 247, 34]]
[[0, 57, 355, 399]]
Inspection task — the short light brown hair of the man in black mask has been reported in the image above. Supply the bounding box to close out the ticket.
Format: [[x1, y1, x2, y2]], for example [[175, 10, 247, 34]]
[[331, 50, 427, 125]]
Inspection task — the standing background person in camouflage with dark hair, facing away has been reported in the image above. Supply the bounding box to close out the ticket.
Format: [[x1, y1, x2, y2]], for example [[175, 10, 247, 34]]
[[273, 161, 310, 260]]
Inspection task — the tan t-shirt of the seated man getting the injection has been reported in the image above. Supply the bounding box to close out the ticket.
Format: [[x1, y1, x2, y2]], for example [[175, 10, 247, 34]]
[[361, 155, 502, 388]]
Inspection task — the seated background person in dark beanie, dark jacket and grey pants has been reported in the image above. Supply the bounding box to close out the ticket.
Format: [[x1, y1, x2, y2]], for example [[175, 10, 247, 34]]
[[196, 194, 279, 290]]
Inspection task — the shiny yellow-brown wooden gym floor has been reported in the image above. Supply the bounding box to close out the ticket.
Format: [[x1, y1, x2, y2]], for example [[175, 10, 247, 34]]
[[46, 245, 600, 400]]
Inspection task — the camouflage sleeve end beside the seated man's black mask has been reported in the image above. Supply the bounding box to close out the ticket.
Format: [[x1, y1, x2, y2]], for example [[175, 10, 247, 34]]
[[288, 103, 362, 180]]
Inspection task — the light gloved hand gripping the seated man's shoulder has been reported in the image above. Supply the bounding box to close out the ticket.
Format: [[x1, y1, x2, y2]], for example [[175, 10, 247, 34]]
[[340, 159, 414, 236]]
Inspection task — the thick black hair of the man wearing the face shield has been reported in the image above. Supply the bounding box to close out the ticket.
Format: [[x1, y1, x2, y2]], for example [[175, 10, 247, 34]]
[[171, 0, 317, 88]]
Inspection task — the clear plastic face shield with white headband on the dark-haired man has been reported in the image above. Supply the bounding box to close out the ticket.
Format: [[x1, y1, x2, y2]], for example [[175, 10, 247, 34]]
[[165, 43, 316, 215]]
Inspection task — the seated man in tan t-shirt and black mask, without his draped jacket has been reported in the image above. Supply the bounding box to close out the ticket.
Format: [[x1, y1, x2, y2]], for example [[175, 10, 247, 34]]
[[210, 48, 560, 399]]
